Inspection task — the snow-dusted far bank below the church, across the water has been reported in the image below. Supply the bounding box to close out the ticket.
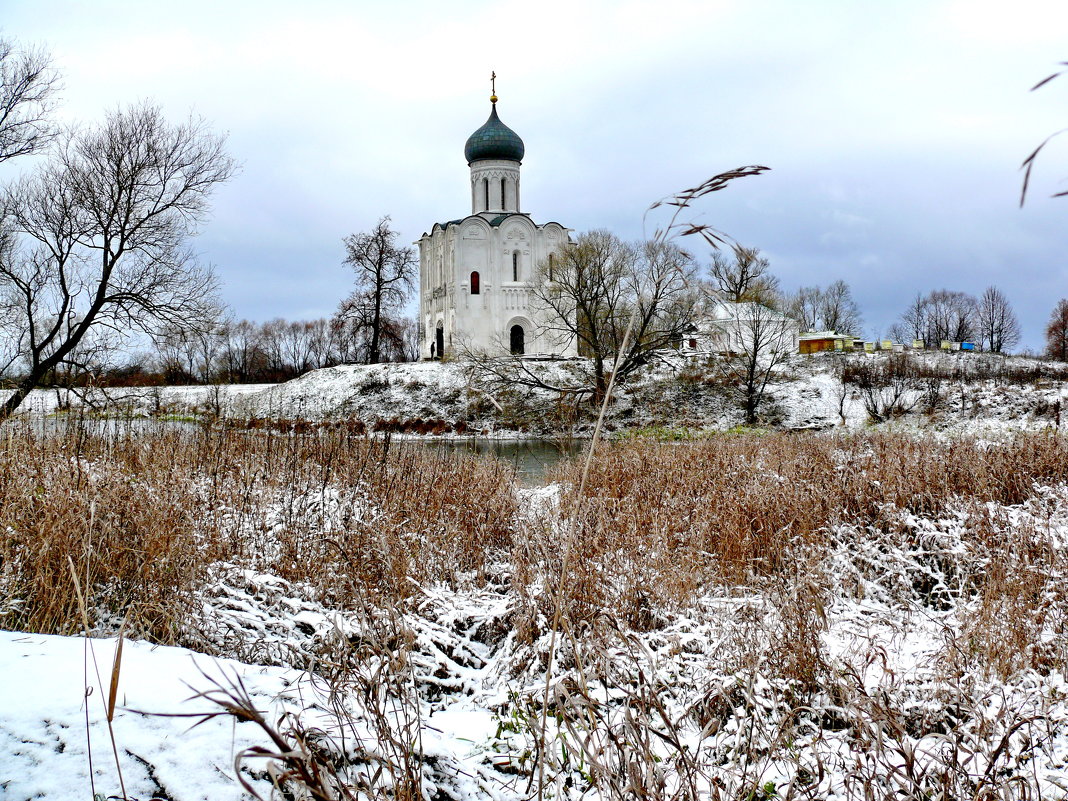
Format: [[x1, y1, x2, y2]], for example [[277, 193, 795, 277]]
[[8, 352, 1068, 437]]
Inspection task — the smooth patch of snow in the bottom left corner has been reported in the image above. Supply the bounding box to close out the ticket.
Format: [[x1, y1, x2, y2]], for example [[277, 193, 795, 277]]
[[0, 631, 296, 801]]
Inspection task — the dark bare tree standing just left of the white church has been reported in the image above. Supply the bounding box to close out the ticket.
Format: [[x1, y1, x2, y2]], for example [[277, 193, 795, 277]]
[[337, 217, 419, 364]]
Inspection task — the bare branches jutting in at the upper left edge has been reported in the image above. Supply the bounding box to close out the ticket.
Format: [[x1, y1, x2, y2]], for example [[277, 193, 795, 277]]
[[0, 38, 60, 162]]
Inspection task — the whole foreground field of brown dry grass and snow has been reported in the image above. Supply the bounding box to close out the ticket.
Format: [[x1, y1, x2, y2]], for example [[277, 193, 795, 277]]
[[0, 420, 1068, 801]]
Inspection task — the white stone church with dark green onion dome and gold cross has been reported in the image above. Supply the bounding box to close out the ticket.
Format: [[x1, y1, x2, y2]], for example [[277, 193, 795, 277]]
[[418, 88, 577, 359]]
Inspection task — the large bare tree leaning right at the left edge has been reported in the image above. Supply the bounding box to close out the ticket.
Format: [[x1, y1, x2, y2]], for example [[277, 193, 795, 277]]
[[0, 105, 235, 420]]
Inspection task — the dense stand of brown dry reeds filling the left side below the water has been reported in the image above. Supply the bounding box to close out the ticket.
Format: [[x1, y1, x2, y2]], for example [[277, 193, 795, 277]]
[[0, 420, 516, 643]]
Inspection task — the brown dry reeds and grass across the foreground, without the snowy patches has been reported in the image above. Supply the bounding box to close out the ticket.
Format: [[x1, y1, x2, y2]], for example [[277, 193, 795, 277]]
[[0, 420, 1068, 801]]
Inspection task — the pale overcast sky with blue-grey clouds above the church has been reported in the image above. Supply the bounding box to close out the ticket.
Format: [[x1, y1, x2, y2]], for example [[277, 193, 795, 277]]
[[0, 0, 1068, 349]]
